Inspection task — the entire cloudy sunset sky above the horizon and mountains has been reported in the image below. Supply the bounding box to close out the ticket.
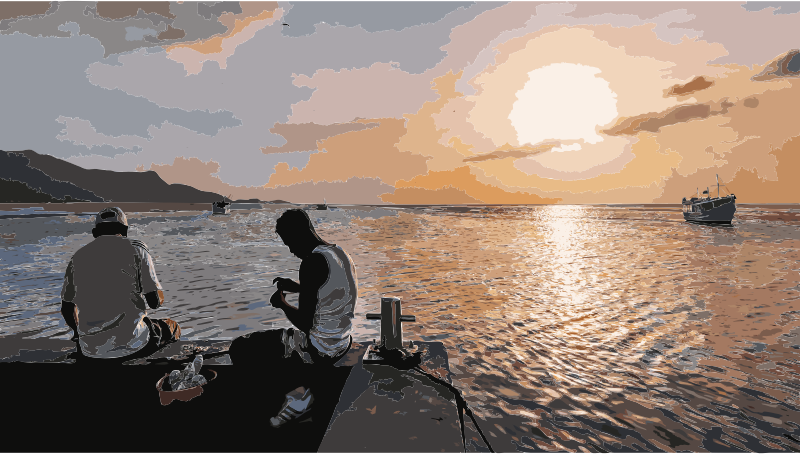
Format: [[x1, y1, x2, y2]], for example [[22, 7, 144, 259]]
[[0, 1, 800, 204]]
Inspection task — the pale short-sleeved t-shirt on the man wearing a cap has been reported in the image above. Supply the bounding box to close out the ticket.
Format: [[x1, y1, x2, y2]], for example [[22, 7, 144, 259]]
[[61, 235, 161, 358]]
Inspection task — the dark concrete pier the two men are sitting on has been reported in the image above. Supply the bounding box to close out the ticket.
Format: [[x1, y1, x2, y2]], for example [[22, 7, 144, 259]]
[[0, 336, 464, 452]]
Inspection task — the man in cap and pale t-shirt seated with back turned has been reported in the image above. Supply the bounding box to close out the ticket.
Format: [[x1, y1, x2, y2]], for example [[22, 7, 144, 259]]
[[61, 207, 181, 358]]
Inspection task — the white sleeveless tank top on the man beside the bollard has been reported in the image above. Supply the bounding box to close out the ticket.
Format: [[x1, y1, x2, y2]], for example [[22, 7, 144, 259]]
[[310, 245, 358, 356]]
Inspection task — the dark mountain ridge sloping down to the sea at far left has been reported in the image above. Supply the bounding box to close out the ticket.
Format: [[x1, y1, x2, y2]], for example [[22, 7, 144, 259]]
[[0, 150, 219, 202]]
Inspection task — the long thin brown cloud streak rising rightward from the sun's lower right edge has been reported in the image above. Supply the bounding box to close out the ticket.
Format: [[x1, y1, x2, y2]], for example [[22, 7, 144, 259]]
[[601, 98, 736, 136]]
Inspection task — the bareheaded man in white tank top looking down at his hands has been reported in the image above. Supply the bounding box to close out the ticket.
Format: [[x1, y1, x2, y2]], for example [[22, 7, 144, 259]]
[[228, 208, 358, 428]]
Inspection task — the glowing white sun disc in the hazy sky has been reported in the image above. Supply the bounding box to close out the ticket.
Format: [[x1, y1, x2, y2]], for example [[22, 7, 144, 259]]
[[508, 63, 617, 146]]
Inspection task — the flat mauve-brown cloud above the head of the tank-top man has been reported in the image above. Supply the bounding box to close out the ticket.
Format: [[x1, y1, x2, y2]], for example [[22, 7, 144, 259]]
[[259, 119, 380, 154]]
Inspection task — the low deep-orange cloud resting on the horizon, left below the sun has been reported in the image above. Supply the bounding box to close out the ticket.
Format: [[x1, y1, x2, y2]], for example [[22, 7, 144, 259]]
[[381, 166, 562, 204]]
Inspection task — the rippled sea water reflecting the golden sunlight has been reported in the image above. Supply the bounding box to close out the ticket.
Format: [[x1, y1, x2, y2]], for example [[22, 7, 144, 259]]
[[0, 205, 800, 452]]
